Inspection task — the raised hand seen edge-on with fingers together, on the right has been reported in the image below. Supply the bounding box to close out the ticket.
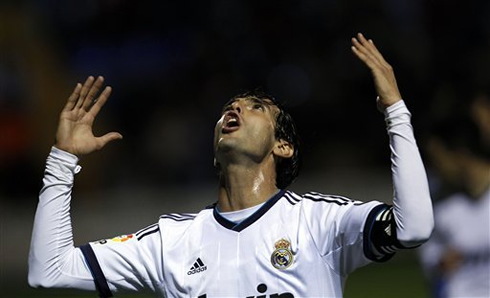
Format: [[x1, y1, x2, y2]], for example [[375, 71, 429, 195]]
[[351, 33, 401, 109]]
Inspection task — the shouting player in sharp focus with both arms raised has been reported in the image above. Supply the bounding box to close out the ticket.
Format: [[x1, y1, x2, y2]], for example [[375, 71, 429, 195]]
[[29, 34, 433, 298]]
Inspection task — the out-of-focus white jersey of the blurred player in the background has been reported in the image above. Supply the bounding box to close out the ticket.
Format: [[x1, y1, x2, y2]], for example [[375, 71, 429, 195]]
[[420, 190, 490, 297]]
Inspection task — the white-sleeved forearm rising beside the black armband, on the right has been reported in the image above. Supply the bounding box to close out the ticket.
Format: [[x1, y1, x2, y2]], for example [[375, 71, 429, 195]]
[[385, 101, 434, 247]]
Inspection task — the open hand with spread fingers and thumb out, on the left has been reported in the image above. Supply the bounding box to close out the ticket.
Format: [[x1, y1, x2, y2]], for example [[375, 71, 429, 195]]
[[55, 76, 122, 156]]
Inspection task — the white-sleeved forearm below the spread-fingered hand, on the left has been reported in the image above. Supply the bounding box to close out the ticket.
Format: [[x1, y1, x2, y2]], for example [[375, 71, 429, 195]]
[[29, 147, 95, 290]]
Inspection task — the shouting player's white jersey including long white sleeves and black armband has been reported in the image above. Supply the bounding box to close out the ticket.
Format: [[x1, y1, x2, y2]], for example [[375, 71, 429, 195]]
[[29, 101, 433, 298]]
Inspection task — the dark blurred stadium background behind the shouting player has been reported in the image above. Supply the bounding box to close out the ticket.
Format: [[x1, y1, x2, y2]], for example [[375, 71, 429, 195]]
[[0, 0, 490, 297]]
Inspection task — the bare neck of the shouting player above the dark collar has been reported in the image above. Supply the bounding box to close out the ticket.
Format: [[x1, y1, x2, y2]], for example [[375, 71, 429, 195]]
[[218, 164, 279, 212]]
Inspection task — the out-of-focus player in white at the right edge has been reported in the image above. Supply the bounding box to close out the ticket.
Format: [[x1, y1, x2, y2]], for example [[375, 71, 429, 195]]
[[420, 116, 490, 298]]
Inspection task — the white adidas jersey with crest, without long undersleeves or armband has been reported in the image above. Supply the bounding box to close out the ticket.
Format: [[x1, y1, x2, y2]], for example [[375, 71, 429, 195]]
[[86, 191, 381, 297]]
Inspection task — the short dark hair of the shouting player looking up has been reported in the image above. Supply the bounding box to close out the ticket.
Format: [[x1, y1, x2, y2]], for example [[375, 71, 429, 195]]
[[228, 89, 301, 189]]
